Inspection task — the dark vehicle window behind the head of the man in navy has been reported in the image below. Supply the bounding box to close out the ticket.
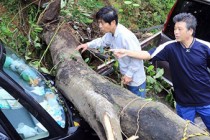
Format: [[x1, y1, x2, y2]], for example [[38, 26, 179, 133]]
[[164, 0, 210, 42]]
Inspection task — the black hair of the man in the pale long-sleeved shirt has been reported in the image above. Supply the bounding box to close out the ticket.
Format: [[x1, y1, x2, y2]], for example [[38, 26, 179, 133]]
[[96, 6, 118, 25]]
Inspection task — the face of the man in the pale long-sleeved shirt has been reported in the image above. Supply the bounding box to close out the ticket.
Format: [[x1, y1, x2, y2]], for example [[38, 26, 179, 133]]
[[98, 19, 115, 33]]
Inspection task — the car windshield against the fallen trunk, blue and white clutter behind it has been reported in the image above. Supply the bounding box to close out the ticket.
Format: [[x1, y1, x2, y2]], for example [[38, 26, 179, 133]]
[[3, 48, 66, 128]]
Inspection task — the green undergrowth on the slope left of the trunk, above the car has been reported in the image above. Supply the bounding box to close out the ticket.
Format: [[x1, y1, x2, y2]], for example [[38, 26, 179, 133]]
[[0, 0, 47, 72]]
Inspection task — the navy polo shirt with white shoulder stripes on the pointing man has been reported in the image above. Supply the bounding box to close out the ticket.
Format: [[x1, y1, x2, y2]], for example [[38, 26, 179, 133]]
[[149, 39, 210, 106]]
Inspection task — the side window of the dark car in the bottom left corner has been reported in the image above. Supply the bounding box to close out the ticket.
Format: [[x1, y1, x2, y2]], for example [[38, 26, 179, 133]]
[[0, 87, 49, 140]]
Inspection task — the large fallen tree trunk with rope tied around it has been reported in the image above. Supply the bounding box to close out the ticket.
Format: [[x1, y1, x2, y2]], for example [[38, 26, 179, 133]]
[[44, 24, 210, 140]]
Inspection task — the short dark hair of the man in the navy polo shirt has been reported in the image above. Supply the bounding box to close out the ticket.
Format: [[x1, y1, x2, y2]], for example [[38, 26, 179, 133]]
[[173, 13, 197, 36]]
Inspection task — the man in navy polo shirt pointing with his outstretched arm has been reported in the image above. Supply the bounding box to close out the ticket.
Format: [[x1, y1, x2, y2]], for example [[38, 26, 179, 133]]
[[113, 13, 210, 130]]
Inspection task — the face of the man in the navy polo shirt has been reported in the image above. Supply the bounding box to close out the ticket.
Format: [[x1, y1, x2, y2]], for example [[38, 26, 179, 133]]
[[174, 21, 193, 42]]
